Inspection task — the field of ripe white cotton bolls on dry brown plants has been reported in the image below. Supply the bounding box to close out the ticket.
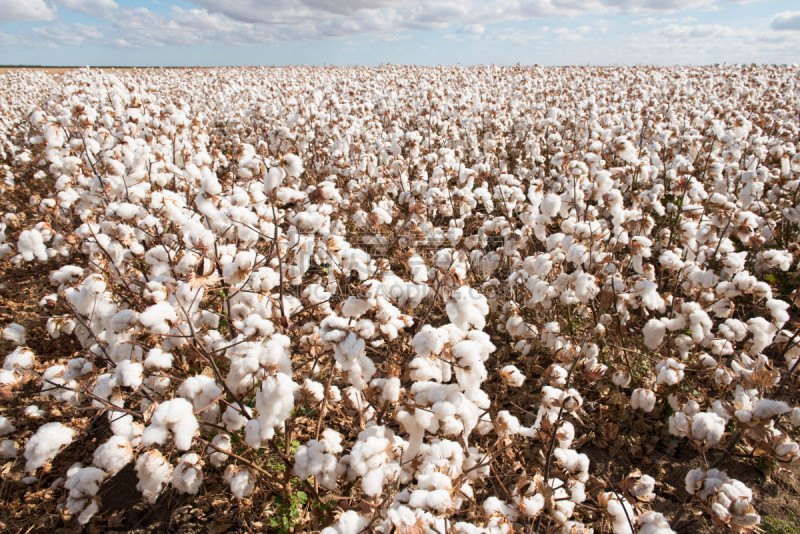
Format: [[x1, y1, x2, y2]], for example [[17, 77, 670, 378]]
[[0, 66, 800, 534]]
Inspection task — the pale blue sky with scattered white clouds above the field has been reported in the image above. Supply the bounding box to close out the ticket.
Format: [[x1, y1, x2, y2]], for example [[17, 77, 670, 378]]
[[0, 0, 800, 66]]
